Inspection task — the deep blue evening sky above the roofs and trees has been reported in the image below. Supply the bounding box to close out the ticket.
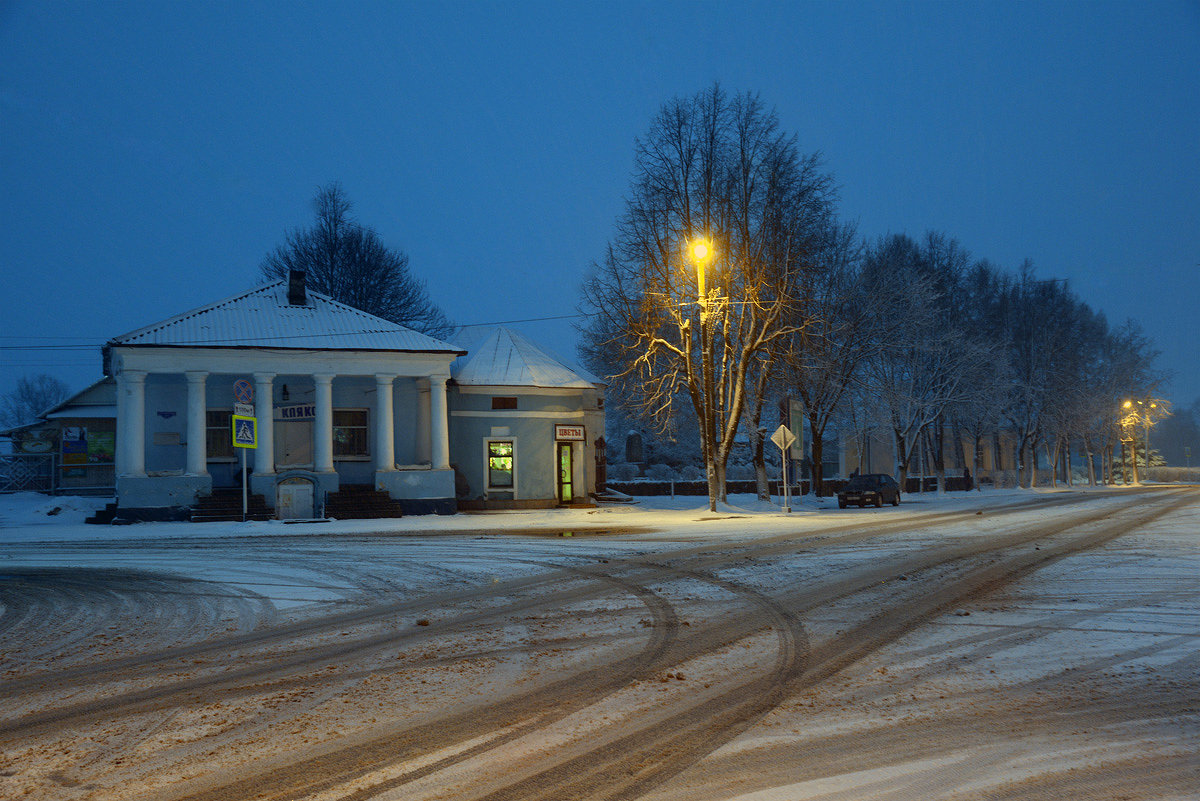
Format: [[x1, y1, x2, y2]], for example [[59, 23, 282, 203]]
[[7, 0, 1200, 403]]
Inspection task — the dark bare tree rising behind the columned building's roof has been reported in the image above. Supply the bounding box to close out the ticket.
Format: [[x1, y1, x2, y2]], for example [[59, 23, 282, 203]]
[[260, 183, 454, 338]]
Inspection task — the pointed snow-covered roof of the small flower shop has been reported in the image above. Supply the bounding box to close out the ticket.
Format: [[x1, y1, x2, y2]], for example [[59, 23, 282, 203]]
[[450, 327, 604, 389]]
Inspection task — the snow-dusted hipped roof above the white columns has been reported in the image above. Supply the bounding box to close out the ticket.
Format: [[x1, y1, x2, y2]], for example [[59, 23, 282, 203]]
[[107, 281, 464, 354]]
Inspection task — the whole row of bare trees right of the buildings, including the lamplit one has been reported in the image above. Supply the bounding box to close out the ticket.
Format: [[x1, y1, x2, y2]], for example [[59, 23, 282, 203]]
[[580, 86, 1156, 508]]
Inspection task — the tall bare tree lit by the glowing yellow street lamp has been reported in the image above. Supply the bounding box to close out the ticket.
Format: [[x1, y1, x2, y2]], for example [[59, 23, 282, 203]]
[[580, 86, 832, 508]]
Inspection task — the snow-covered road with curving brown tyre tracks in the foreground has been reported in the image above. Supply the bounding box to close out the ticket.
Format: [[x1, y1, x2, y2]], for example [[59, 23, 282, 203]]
[[0, 488, 1200, 801]]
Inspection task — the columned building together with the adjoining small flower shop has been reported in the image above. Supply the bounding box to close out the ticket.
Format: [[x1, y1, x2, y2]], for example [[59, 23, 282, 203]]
[[85, 275, 604, 518]]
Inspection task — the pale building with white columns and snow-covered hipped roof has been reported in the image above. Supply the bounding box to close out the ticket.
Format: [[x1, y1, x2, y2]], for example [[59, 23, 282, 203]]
[[104, 276, 466, 517]]
